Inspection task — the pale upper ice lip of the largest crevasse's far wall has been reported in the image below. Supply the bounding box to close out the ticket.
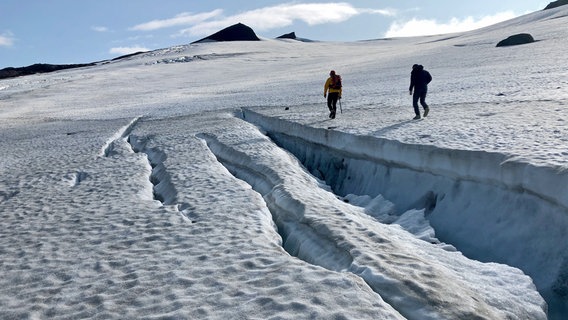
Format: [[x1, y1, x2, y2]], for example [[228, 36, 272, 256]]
[[241, 109, 568, 209]]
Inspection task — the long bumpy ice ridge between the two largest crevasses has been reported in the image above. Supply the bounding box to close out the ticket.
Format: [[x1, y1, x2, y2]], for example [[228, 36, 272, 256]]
[[199, 116, 545, 319]]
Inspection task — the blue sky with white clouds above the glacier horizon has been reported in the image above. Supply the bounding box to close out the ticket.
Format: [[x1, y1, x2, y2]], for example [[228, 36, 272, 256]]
[[0, 0, 550, 68]]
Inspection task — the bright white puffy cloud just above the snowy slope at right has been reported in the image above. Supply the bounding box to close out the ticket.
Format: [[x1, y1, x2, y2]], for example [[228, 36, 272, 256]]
[[385, 11, 516, 37]]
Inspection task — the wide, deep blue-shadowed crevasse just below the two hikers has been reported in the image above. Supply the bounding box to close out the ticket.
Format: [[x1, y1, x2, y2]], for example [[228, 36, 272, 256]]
[[241, 109, 568, 316]]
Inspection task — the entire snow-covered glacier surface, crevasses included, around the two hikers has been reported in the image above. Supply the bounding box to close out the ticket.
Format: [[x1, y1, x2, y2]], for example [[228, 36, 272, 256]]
[[0, 7, 568, 319]]
